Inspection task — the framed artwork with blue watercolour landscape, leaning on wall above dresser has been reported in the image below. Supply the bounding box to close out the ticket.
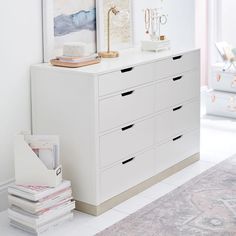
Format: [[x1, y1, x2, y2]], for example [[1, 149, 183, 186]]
[[43, 0, 99, 62]]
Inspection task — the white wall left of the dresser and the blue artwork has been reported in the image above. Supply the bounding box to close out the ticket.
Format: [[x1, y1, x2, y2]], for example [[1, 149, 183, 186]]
[[0, 0, 42, 197]]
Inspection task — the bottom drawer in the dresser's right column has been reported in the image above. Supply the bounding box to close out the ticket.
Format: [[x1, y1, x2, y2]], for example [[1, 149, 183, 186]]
[[155, 130, 200, 173]]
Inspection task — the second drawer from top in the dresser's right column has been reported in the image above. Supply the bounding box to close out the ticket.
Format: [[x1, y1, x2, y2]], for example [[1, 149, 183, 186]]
[[156, 70, 200, 111]]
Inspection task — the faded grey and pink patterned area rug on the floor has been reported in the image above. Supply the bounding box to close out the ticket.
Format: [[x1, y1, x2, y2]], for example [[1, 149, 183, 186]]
[[97, 156, 236, 236]]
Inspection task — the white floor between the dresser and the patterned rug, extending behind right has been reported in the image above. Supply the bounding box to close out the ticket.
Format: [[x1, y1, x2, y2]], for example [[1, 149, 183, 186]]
[[0, 113, 236, 236]]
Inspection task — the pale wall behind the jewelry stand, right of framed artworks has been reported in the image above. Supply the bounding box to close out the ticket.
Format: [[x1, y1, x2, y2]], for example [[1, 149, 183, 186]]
[[133, 0, 195, 48]]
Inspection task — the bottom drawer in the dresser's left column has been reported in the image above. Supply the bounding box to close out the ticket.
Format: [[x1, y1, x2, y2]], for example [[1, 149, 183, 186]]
[[101, 150, 155, 202]]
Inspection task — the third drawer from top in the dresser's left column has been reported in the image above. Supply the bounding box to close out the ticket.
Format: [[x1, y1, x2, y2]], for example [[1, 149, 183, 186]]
[[100, 118, 155, 168]]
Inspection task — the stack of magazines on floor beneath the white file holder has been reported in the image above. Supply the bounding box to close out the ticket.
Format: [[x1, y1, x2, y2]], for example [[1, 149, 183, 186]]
[[8, 181, 75, 234]]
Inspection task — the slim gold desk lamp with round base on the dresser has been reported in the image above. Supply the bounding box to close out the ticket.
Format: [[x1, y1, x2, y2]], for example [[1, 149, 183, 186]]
[[98, 6, 119, 58]]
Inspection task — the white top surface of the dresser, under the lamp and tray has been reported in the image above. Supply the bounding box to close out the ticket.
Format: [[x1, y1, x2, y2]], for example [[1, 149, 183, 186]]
[[32, 48, 199, 75]]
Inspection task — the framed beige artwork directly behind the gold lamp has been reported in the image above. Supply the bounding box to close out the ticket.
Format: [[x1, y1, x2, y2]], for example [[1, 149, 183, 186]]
[[98, 0, 133, 50]]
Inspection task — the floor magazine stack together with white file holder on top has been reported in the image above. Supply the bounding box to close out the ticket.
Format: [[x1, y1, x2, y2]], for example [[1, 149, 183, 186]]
[[8, 135, 75, 235]]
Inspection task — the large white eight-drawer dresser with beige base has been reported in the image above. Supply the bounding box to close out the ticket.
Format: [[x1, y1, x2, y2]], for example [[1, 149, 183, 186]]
[[31, 49, 200, 215]]
